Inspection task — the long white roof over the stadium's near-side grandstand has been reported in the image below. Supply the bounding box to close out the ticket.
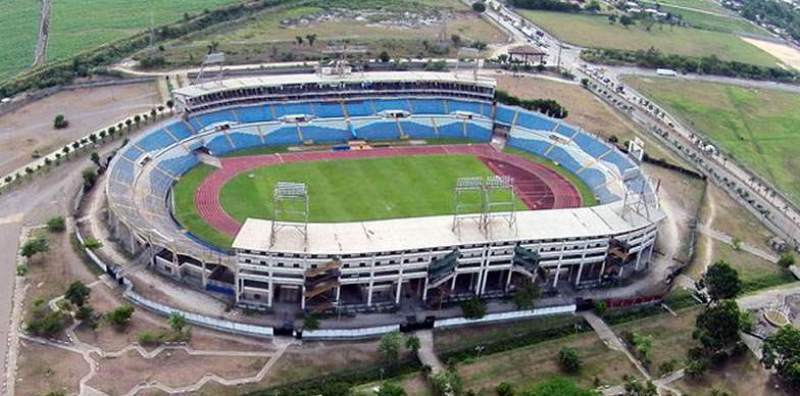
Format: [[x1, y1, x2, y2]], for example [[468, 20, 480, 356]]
[[233, 202, 663, 254]]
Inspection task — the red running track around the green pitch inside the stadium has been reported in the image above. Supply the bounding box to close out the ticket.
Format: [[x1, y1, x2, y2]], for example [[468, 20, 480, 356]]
[[194, 144, 581, 237]]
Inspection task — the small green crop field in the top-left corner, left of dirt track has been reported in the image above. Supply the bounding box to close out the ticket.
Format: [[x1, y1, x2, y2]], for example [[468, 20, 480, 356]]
[[0, 0, 41, 81]]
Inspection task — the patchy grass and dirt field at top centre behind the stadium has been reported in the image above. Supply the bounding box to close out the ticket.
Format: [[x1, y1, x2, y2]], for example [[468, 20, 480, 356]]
[[147, 0, 505, 65]]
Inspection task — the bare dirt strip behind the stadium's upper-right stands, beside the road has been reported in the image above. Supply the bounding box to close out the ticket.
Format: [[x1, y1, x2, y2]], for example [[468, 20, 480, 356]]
[[496, 75, 683, 164]]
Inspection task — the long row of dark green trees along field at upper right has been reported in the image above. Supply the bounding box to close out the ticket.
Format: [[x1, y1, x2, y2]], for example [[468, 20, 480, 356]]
[[581, 47, 800, 82]]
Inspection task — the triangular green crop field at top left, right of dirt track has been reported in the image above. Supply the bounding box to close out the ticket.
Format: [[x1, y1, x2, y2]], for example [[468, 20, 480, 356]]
[[45, 0, 241, 60]]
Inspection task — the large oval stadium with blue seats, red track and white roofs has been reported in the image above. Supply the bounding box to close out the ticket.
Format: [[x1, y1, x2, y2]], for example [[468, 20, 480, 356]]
[[105, 72, 664, 318]]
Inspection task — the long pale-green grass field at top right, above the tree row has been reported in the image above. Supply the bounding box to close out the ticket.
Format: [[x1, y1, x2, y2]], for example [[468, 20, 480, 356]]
[[522, 11, 778, 66]]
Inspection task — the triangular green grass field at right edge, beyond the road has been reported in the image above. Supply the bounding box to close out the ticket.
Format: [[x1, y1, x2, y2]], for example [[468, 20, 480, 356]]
[[625, 78, 800, 202]]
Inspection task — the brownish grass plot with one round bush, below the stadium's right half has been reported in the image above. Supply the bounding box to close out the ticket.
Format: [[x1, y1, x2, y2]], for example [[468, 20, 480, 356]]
[[458, 332, 639, 396]]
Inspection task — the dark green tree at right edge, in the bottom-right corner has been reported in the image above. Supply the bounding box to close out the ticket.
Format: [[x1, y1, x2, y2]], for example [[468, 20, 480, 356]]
[[761, 326, 800, 390]]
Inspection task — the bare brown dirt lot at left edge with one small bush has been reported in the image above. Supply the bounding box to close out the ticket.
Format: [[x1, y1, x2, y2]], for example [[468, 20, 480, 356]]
[[0, 83, 159, 174]]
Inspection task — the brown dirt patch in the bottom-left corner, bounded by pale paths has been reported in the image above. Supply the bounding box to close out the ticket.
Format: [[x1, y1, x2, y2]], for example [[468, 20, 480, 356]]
[[15, 340, 89, 395]]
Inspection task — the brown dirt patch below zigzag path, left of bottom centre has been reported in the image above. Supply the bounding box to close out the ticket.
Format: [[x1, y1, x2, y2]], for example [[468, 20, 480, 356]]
[[89, 350, 267, 395]]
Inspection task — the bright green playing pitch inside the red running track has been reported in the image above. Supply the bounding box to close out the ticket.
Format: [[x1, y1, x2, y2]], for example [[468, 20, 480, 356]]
[[220, 155, 524, 222]]
